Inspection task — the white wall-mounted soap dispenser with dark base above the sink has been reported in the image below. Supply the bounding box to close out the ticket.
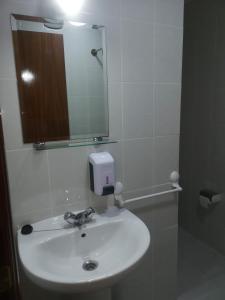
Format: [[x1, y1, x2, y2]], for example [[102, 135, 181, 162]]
[[89, 152, 115, 196]]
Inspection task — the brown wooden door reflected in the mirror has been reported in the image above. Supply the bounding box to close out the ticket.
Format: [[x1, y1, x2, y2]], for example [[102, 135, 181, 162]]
[[13, 30, 70, 143]]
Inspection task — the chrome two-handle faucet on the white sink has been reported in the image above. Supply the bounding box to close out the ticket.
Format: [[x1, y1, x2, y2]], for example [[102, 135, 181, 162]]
[[64, 207, 95, 227]]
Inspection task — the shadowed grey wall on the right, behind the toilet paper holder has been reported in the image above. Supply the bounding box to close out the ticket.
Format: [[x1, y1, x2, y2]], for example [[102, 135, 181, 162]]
[[179, 0, 225, 254]]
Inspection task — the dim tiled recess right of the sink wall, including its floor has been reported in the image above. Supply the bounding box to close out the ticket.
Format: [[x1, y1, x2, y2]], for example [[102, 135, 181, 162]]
[[178, 0, 225, 300]]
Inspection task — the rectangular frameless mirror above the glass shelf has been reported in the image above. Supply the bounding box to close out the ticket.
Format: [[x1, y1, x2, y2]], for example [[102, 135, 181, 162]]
[[11, 14, 109, 143]]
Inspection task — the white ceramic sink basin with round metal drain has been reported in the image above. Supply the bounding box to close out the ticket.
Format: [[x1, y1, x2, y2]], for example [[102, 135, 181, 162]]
[[18, 208, 150, 292]]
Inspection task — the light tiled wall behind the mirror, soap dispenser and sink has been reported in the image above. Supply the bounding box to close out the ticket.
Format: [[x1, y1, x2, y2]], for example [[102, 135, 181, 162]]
[[0, 0, 183, 300]]
